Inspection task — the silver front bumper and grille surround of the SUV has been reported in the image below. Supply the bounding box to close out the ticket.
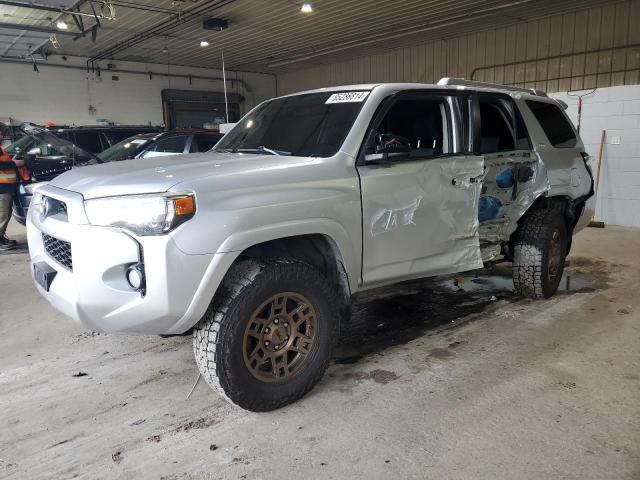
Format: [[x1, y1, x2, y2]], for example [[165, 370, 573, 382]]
[[27, 186, 235, 334]]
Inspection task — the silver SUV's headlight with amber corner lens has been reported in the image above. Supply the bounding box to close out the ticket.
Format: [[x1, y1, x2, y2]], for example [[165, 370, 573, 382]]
[[84, 193, 196, 235]]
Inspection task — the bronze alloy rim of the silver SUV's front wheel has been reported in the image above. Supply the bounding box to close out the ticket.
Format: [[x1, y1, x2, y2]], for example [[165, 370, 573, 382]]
[[242, 292, 317, 382]]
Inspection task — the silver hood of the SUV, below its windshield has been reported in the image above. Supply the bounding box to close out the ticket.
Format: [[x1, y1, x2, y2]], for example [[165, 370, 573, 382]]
[[51, 152, 313, 199]]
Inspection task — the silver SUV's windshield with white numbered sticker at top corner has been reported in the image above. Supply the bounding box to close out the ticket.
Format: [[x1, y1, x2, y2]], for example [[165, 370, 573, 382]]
[[215, 91, 369, 157]]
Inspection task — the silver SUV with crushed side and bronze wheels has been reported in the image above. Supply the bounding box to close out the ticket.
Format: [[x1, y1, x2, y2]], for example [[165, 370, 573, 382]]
[[28, 79, 593, 411]]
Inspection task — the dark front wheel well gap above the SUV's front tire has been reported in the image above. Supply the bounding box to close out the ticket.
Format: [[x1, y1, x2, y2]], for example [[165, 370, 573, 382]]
[[236, 233, 351, 319]]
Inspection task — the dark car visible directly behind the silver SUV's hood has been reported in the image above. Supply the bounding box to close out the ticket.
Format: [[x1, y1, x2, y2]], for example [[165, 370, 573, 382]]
[[98, 130, 224, 162]]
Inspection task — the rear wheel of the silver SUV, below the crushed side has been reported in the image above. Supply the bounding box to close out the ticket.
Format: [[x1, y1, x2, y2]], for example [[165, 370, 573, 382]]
[[513, 209, 567, 298]]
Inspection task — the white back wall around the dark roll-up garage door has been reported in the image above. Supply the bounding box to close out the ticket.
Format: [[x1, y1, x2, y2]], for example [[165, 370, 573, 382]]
[[0, 57, 276, 125]]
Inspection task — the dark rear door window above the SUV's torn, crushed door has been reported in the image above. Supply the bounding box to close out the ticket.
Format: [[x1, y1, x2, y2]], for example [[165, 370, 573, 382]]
[[478, 94, 531, 153]]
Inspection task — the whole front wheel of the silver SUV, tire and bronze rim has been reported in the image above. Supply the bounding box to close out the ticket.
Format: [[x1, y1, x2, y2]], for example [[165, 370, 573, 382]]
[[193, 259, 340, 411]]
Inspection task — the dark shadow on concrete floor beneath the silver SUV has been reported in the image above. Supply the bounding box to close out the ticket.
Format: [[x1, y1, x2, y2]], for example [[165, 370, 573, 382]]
[[333, 264, 592, 364]]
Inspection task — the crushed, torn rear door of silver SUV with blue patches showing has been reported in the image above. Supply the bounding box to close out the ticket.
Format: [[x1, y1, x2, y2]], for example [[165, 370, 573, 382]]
[[478, 151, 549, 245]]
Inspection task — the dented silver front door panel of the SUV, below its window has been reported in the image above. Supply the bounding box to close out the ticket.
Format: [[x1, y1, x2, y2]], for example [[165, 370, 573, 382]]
[[358, 156, 484, 286]]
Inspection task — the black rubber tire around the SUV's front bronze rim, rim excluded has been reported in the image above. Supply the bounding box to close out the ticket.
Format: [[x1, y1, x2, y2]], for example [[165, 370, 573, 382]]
[[193, 259, 340, 412]]
